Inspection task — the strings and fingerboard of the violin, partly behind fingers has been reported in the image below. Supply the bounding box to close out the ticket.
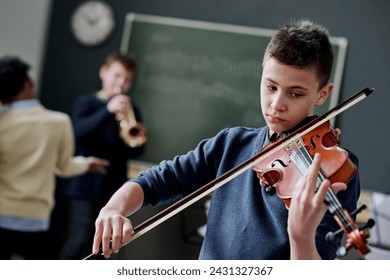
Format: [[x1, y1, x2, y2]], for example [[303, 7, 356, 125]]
[[291, 140, 352, 231]]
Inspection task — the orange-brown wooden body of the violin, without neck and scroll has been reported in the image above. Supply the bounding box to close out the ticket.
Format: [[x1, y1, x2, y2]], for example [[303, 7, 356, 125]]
[[253, 121, 356, 208]]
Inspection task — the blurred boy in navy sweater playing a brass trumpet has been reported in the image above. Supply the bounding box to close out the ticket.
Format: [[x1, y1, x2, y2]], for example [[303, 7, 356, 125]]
[[60, 52, 147, 259]]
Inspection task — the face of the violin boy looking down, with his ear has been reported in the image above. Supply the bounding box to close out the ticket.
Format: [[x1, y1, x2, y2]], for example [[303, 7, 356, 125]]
[[260, 57, 333, 133]]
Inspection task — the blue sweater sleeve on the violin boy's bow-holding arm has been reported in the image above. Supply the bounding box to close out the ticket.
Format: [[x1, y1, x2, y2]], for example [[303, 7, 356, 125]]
[[133, 129, 229, 205]]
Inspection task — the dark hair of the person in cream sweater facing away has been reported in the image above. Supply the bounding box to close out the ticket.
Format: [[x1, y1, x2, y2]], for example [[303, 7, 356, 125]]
[[0, 56, 30, 100]]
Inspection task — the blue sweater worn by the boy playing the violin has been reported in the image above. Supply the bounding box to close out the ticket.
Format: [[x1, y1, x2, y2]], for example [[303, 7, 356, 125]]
[[134, 127, 360, 260]]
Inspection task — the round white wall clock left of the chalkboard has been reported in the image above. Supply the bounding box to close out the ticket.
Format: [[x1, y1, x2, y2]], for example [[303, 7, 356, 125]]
[[71, 1, 115, 46]]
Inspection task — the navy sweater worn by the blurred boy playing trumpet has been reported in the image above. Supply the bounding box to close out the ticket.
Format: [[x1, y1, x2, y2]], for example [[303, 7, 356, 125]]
[[65, 93, 144, 203]]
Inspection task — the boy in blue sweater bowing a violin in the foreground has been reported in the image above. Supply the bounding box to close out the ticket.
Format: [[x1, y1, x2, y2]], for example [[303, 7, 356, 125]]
[[93, 20, 360, 259]]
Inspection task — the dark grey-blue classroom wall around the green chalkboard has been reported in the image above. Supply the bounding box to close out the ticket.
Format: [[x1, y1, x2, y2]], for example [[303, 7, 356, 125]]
[[41, 0, 390, 196]]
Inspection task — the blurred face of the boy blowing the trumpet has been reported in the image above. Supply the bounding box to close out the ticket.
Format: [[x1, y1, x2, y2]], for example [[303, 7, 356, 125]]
[[99, 62, 134, 98]]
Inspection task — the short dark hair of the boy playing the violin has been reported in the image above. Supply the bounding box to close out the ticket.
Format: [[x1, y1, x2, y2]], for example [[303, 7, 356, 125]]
[[264, 19, 333, 88]]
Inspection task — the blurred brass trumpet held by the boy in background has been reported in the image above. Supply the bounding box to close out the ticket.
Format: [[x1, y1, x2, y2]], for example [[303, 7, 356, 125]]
[[119, 97, 147, 148]]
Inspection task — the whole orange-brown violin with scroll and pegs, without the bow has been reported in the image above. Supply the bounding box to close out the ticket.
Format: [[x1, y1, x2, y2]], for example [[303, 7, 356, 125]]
[[252, 121, 374, 256]]
